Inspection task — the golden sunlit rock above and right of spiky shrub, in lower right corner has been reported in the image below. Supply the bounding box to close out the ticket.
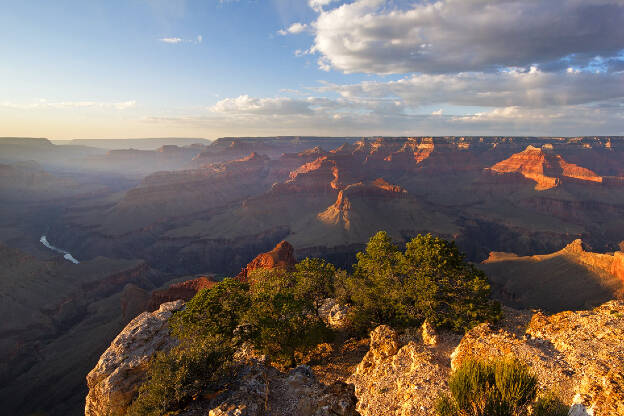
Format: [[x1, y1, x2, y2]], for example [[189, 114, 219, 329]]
[[452, 301, 624, 416]]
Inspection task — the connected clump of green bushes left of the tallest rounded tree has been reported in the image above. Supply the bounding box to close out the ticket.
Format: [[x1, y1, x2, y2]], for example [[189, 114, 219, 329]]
[[128, 259, 336, 416]]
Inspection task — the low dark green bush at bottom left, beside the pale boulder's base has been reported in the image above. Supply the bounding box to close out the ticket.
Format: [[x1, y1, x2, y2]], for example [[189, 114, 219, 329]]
[[127, 338, 233, 416]]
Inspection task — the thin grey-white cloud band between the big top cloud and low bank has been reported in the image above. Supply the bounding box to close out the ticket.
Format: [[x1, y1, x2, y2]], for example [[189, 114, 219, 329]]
[[320, 67, 624, 108]]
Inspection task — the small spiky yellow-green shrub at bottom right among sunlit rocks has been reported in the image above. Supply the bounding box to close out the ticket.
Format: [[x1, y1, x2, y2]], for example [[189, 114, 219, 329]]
[[436, 359, 537, 416]]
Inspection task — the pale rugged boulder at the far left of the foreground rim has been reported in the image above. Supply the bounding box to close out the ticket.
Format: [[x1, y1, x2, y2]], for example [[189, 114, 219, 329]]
[[85, 300, 184, 416]]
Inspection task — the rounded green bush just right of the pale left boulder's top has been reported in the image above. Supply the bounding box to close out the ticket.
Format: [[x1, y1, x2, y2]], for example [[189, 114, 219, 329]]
[[169, 278, 251, 339]]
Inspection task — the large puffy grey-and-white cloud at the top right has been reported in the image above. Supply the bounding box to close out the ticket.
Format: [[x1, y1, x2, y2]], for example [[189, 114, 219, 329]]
[[309, 0, 624, 74]]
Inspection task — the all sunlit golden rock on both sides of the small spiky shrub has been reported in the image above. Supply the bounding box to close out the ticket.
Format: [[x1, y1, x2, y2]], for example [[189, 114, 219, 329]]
[[348, 301, 624, 416]]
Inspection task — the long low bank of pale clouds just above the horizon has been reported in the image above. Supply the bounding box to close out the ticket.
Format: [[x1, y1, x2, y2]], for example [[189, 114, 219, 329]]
[[145, 97, 624, 136]]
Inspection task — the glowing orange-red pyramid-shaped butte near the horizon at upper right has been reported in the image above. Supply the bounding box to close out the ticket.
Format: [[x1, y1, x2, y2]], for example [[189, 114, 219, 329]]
[[489, 145, 603, 191]]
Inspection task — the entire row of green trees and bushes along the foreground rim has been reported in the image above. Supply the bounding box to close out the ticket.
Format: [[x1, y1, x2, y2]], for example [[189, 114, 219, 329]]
[[129, 231, 502, 415]]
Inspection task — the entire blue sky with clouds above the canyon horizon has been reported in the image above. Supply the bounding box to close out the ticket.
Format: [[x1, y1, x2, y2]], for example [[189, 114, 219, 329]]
[[0, 0, 624, 139]]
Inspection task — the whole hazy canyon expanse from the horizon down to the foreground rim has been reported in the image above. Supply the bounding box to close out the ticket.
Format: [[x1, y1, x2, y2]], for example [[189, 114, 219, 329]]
[[0, 136, 624, 416]]
